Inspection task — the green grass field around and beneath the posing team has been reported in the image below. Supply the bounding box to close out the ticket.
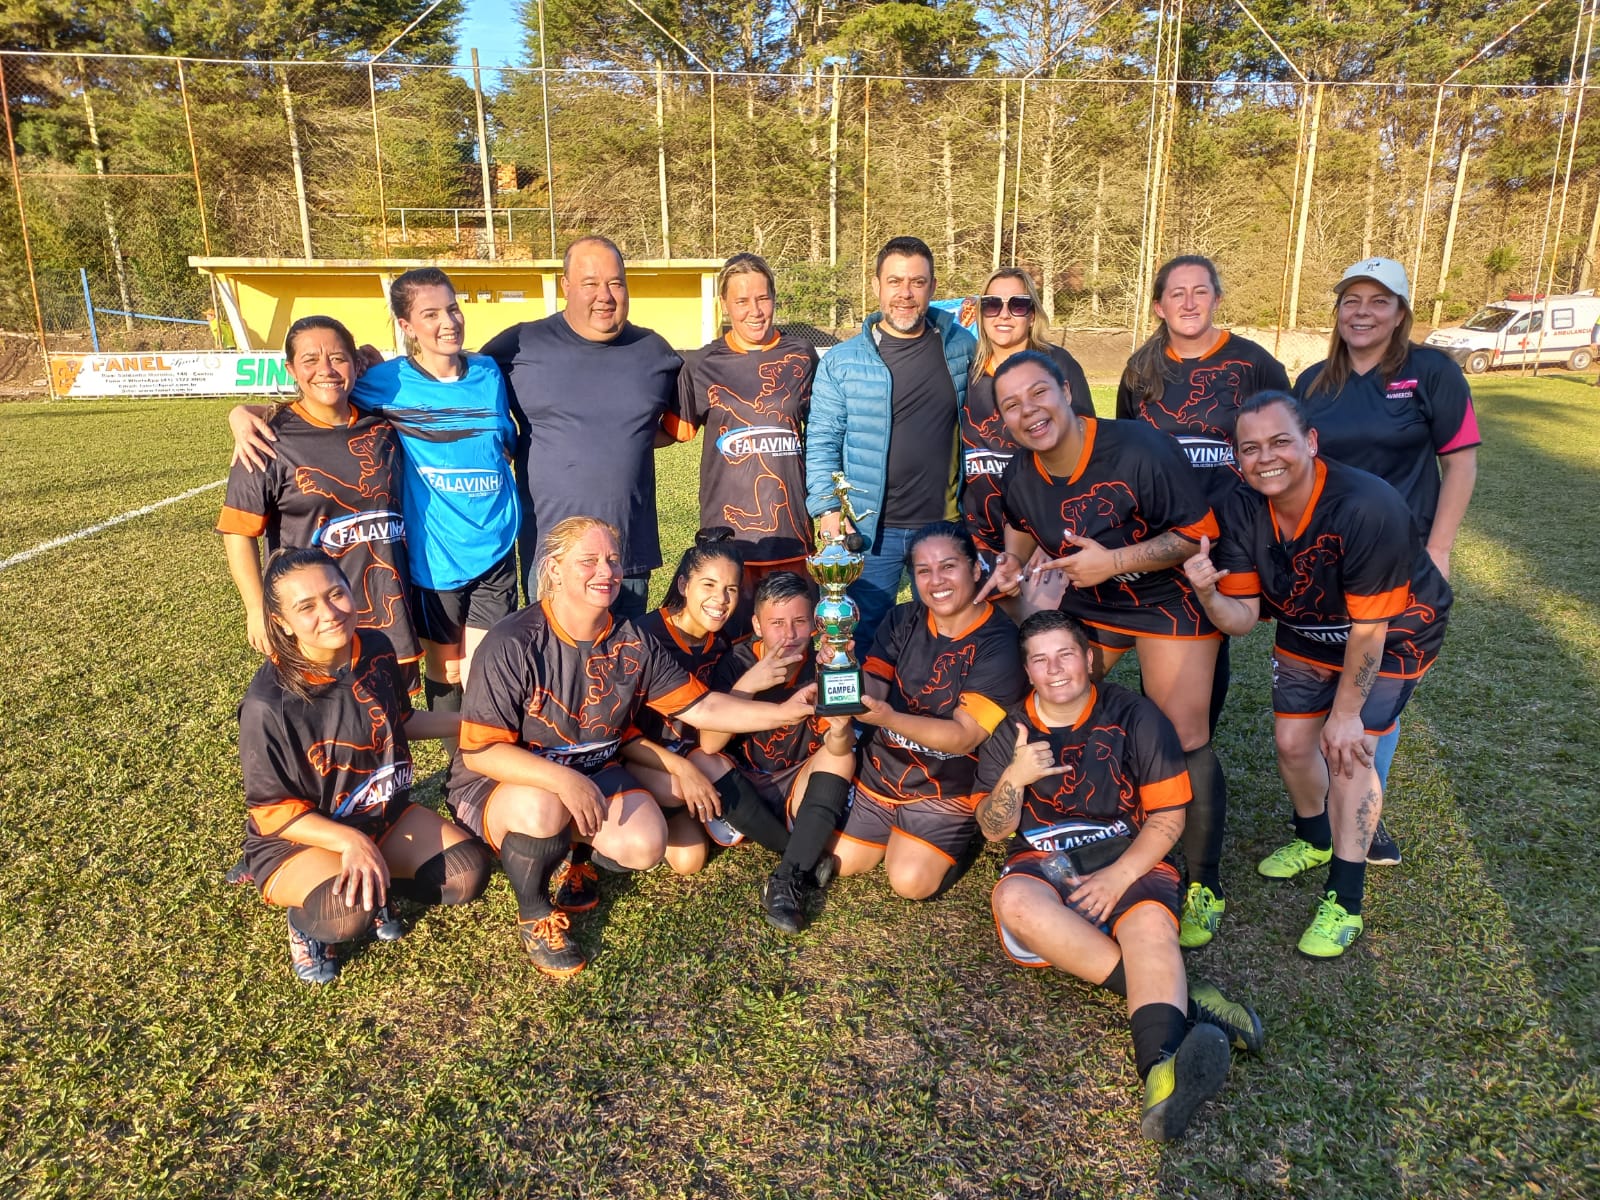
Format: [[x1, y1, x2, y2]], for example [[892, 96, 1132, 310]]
[[0, 376, 1600, 1200]]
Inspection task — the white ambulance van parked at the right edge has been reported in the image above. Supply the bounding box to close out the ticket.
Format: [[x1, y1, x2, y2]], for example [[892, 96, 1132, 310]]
[[1426, 291, 1600, 374]]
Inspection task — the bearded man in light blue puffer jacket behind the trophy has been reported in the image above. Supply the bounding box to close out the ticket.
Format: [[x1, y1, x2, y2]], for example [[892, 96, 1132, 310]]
[[805, 237, 978, 658]]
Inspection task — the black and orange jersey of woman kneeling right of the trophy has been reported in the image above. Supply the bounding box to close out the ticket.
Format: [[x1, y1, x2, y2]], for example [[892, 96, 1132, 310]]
[[856, 600, 1027, 808]]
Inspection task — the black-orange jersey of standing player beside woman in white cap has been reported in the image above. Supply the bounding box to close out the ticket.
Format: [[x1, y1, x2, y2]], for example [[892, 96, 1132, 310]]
[[1117, 331, 1290, 507]]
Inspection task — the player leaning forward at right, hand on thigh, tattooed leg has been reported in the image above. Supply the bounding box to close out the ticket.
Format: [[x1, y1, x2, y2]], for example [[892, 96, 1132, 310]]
[[1184, 400, 1451, 958]]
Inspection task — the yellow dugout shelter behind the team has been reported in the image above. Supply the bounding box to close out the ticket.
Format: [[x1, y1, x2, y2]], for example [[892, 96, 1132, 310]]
[[189, 258, 722, 352]]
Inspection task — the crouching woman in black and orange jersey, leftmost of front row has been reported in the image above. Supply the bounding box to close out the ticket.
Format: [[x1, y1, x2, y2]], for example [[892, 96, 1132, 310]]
[[238, 547, 488, 984]]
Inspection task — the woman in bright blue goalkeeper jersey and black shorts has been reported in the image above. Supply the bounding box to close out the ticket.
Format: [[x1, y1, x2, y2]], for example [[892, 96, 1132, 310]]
[[229, 267, 522, 712]]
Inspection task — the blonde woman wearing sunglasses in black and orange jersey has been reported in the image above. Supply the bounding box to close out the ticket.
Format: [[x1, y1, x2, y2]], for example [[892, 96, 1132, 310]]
[[962, 267, 1094, 562]]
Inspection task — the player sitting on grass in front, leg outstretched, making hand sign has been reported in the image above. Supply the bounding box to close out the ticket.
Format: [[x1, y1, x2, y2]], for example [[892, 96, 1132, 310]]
[[978, 610, 1262, 1141]]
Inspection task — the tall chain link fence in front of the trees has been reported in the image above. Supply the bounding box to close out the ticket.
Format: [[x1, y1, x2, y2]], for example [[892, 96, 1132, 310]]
[[0, 53, 1600, 360]]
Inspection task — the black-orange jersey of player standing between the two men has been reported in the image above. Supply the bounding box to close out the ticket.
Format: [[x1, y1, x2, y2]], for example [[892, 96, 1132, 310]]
[[667, 334, 818, 565]]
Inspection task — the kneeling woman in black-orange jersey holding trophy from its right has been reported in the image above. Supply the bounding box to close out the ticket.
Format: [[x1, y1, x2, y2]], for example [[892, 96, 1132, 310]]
[[837, 522, 1024, 899]]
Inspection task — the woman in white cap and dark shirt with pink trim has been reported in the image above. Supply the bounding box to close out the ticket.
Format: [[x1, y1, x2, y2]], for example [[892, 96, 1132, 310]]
[[1294, 258, 1482, 864]]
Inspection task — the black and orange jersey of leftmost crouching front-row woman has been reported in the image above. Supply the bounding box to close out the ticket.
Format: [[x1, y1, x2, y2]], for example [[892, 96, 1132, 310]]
[[238, 630, 411, 857]]
